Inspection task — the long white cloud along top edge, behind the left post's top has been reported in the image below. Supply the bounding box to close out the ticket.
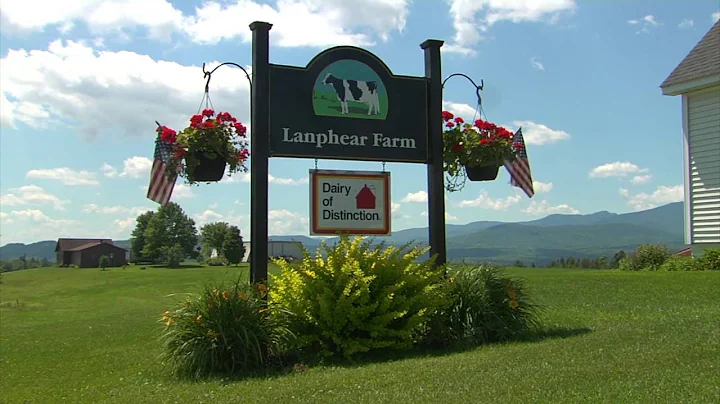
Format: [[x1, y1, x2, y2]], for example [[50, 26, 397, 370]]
[[2, 0, 409, 47]]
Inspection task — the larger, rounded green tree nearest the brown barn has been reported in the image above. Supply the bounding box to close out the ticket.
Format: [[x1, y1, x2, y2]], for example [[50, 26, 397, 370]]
[[143, 202, 198, 261]]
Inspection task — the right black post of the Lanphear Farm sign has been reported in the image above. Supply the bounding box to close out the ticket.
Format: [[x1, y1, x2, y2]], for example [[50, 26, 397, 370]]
[[420, 39, 447, 265]]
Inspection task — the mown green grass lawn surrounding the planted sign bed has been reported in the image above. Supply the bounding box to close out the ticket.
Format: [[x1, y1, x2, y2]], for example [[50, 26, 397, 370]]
[[0, 267, 720, 403]]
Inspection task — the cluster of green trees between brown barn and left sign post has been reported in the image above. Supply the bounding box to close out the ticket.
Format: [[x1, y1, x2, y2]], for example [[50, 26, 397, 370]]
[[130, 202, 245, 268]]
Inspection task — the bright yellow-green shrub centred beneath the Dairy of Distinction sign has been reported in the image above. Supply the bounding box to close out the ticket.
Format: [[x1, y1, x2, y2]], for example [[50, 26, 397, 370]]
[[270, 236, 444, 359]]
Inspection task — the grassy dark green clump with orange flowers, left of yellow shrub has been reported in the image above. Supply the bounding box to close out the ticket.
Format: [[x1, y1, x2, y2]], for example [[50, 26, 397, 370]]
[[160, 281, 292, 379]]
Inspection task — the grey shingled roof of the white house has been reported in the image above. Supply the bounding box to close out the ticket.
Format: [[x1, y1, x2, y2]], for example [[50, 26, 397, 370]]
[[660, 20, 720, 88]]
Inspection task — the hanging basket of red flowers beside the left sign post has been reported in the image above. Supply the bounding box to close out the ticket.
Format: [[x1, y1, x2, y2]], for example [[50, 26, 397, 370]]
[[158, 109, 250, 185]]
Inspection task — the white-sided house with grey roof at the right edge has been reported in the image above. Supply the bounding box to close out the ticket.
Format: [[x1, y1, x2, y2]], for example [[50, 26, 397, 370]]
[[660, 21, 720, 256]]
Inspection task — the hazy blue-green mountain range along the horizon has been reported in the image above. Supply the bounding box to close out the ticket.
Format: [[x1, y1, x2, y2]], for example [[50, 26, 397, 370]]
[[0, 202, 685, 265]]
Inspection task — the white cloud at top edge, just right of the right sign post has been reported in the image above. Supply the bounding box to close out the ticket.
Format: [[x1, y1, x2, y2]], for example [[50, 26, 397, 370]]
[[443, 0, 576, 55]]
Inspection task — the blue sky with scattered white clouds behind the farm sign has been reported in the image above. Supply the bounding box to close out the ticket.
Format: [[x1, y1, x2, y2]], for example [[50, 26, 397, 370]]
[[0, 0, 720, 244]]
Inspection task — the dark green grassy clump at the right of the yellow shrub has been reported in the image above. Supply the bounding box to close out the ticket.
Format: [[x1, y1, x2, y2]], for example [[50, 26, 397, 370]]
[[426, 264, 540, 345]]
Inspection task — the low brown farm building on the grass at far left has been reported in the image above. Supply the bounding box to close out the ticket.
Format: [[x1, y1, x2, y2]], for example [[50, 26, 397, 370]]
[[55, 238, 128, 268]]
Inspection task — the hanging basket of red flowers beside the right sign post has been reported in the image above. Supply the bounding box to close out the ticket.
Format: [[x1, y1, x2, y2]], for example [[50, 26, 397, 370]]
[[443, 111, 522, 192]]
